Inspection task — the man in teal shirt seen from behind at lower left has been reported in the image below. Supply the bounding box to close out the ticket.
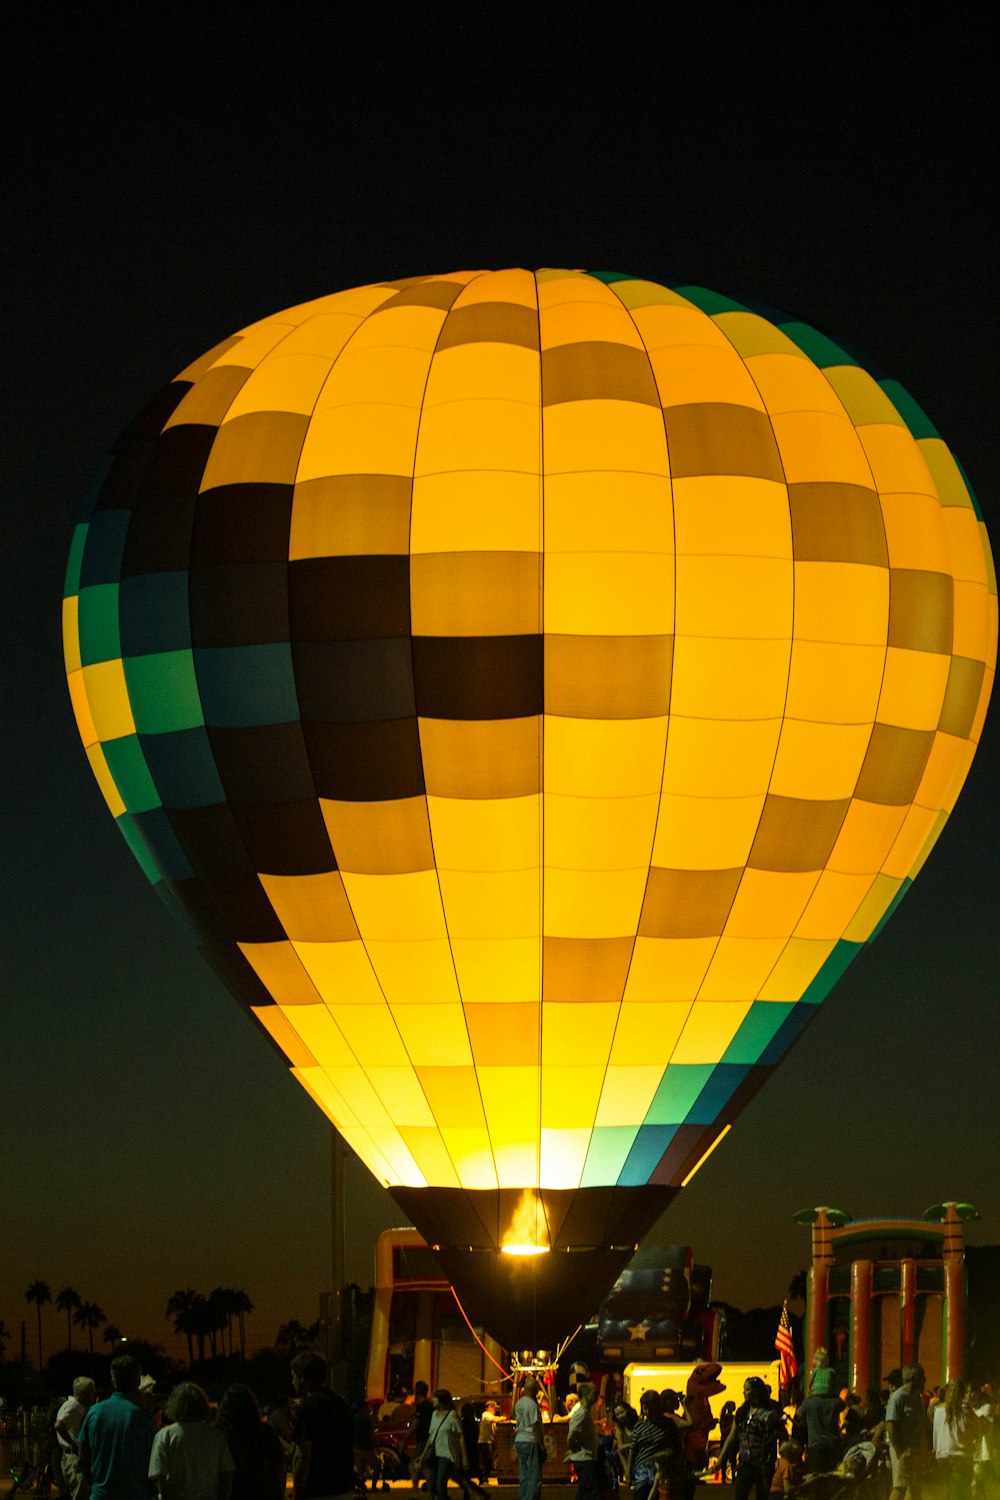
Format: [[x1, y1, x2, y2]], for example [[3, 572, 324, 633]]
[[76, 1355, 154, 1500]]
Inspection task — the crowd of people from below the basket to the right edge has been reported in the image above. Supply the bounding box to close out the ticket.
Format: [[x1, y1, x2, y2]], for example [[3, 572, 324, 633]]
[[514, 1350, 1000, 1500]]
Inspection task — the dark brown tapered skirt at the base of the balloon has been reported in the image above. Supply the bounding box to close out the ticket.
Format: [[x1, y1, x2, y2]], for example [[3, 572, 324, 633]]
[[391, 1185, 679, 1349]]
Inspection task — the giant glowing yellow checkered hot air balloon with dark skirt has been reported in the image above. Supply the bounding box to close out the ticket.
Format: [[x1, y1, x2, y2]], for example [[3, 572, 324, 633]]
[[64, 270, 997, 1347]]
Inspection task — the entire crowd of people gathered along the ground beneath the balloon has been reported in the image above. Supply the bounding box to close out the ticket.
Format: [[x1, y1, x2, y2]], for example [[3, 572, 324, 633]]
[[13, 1350, 1000, 1500]]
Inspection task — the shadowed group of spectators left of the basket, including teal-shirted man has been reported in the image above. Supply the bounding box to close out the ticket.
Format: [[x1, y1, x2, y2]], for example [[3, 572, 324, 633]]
[[12, 1350, 357, 1500]]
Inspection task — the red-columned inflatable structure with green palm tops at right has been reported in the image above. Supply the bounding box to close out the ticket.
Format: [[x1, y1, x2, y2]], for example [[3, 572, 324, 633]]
[[795, 1202, 979, 1394]]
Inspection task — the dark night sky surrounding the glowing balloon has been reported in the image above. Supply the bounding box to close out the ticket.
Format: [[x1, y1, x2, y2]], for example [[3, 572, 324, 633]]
[[0, 17, 1000, 1353]]
